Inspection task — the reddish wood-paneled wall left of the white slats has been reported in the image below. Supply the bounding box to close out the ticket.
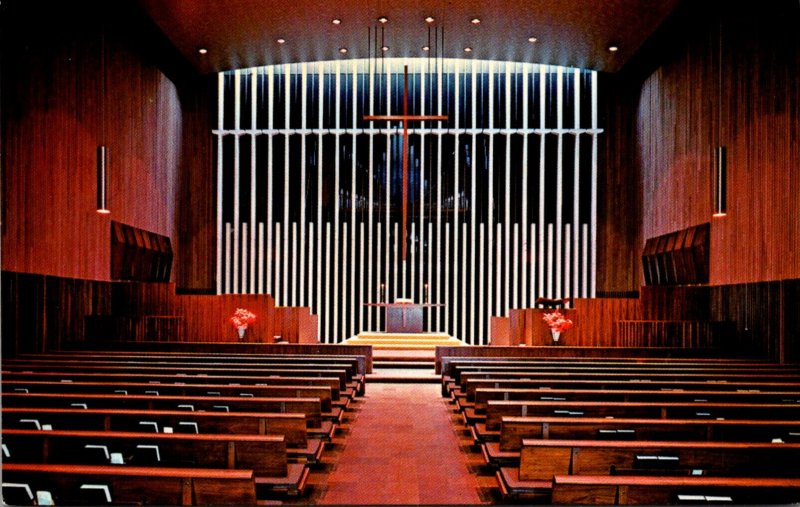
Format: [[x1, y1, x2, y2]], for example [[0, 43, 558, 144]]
[[0, 0, 214, 287]]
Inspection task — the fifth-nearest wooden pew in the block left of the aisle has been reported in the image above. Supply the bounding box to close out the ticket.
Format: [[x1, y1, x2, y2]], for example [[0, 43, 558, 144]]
[[2, 380, 342, 422]]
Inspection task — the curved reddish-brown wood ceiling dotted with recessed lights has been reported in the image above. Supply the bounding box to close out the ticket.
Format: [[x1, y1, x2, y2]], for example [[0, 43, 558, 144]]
[[138, 0, 681, 73]]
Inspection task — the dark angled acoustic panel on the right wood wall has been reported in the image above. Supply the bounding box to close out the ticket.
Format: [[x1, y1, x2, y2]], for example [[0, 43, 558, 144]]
[[642, 222, 711, 285]]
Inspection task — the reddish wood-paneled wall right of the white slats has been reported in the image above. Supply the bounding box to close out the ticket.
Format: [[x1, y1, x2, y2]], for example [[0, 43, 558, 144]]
[[608, 0, 800, 285]]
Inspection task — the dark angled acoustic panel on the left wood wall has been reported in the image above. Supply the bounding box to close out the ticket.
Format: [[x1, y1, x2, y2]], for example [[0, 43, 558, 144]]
[[111, 220, 173, 282]]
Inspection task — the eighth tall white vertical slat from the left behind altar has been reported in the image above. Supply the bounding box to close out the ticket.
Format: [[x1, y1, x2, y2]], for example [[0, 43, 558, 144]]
[[334, 60, 342, 343]]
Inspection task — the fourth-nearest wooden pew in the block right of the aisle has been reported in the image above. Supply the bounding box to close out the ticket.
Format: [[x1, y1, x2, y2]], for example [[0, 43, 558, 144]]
[[478, 400, 800, 430]]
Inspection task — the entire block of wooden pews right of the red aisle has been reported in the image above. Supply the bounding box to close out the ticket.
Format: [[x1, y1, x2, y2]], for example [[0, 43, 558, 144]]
[[442, 357, 800, 505]]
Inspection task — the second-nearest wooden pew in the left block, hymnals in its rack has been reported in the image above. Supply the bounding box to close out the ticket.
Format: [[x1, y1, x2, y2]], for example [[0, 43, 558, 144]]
[[2, 428, 309, 494]]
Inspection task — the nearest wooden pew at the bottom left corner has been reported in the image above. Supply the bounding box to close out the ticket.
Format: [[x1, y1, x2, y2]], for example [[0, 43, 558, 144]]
[[3, 463, 258, 505]]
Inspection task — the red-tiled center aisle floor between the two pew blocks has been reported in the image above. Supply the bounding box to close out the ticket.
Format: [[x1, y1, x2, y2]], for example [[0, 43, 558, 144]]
[[316, 383, 490, 505]]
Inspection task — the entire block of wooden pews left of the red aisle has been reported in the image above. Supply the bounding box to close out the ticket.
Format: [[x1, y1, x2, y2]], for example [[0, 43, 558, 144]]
[[2, 351, 366, 505]]
